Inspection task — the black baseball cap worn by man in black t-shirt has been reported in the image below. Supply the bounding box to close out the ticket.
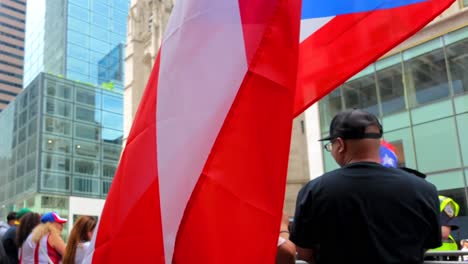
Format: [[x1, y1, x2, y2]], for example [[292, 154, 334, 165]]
[[319, 109, 383, 141]]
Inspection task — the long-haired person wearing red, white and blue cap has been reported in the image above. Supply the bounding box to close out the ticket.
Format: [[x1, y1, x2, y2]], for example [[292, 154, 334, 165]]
[[20, 212, 67, 264]]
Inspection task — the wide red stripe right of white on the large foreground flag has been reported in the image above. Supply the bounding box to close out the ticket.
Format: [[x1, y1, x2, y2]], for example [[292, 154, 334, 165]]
[[173, 0, 300, 263]]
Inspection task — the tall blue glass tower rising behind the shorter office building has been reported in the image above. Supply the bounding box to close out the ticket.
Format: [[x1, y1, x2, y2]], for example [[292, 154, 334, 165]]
[[24, 0, 129, 92]]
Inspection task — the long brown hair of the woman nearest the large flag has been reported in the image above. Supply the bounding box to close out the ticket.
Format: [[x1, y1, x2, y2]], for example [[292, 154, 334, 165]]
[[63, 215, 96, 264]]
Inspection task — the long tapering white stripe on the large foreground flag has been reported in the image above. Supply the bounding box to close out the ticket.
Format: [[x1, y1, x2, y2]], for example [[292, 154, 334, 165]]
[[156, 0, 247, 263]]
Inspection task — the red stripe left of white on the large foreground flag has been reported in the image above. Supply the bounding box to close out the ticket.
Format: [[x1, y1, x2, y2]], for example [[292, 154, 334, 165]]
[[93, 55, 164, 263]]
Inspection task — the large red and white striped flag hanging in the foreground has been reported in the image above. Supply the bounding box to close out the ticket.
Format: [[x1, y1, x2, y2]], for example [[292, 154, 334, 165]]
[[83, 0, 301, 263]]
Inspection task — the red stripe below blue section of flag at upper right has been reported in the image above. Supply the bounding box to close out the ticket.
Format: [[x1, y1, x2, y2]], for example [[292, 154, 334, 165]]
[[294, 0, 454, 115]]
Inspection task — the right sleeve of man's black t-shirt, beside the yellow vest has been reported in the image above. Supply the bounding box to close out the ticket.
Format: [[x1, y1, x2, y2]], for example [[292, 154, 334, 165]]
[[424, 184, 442, 249]]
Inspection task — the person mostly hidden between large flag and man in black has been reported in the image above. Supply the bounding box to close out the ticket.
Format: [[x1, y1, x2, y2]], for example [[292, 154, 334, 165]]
[[276, 213, 296, 264]]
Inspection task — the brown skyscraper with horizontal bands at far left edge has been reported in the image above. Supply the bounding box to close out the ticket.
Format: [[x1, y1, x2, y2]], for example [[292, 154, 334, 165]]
[[0, 0, 26, 112]]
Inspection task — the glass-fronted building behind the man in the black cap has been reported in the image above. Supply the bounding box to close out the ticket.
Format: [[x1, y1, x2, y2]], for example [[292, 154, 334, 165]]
[[319, 27, 468, 238]]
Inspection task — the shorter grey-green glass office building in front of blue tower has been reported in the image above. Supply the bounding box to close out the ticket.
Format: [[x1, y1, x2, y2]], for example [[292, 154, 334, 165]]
[[0, 73, 122, 215]]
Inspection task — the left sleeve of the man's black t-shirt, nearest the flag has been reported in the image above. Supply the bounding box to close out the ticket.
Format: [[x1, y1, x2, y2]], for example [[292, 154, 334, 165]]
[[289, 178, 319, 248]]
